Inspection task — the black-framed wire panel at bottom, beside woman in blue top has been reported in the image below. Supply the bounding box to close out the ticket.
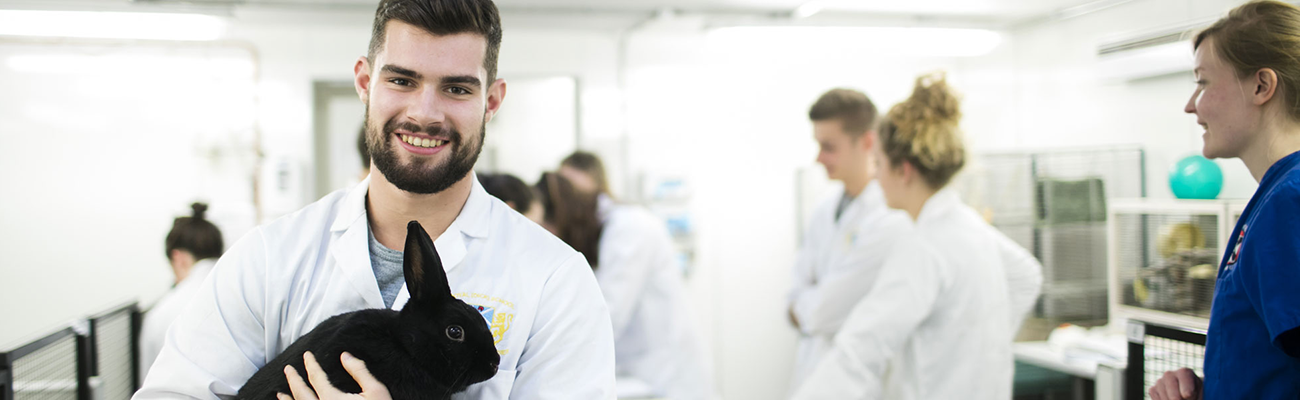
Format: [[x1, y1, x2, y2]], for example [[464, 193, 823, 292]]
[[1125, 319, 1205, 399]]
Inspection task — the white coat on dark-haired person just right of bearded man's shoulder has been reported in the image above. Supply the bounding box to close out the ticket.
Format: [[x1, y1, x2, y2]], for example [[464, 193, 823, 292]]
[[595, 196, 714, 400]]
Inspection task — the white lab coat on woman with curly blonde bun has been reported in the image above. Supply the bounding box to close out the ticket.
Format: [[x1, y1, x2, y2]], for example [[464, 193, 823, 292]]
[[794, 190, 1043, 400]]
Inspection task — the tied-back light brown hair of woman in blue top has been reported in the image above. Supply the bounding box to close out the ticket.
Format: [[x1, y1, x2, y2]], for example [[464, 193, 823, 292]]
[[1192, 0, 1300, 121]]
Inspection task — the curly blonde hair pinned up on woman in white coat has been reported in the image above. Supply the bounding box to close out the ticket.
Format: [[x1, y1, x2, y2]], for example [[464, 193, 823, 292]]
[[879, 73, 966, 188]]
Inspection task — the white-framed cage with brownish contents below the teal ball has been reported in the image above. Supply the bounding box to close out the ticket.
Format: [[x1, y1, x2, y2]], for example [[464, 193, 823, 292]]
[[1114, 208, 1223, 318]]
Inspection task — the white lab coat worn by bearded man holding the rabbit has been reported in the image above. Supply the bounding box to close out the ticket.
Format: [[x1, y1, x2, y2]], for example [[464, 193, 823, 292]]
[[135, 177, 614, 400]]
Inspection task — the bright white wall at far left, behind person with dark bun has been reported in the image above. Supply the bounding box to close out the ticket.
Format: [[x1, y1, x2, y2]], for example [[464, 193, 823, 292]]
[[0, 40, 255, 343]]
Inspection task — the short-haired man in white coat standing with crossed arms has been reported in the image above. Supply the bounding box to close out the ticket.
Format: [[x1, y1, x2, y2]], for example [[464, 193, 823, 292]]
[[789, 88, 911, 388]]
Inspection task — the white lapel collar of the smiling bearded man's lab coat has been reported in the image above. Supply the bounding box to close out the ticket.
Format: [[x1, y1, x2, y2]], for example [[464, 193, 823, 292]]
[[330, 173, 491, 309]]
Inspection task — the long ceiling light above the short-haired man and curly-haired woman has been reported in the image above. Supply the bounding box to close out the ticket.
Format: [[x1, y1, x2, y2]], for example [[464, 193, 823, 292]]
[[709, 26, 1002, 57]]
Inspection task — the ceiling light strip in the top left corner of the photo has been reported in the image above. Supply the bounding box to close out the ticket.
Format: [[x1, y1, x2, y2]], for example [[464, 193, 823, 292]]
[[0, 10, 225, 40]]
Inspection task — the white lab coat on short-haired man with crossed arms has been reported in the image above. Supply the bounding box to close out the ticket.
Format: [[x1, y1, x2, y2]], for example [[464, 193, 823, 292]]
[[789, 181, 911, 390]]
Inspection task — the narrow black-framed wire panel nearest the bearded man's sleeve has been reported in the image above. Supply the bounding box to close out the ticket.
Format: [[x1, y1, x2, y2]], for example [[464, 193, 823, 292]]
[[90, 303, 140, 400]]
